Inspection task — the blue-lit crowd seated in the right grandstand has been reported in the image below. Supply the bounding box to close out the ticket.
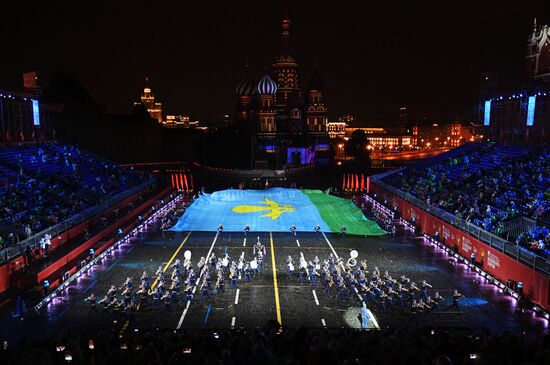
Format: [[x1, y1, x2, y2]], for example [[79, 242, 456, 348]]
[[386, 145, 550, 254]]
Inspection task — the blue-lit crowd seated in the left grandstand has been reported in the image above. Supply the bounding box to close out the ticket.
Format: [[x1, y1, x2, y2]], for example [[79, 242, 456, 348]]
[[0, 142, 148, 246]]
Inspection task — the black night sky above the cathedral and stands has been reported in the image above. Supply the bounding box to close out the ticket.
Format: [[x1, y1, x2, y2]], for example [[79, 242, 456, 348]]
[[0, 0, 550, 124]]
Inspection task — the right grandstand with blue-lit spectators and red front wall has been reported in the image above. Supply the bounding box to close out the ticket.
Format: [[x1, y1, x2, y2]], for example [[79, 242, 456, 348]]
[[369, 143, 550, 324]]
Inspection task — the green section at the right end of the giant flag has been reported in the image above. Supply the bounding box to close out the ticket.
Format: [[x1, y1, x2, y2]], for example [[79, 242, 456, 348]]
[[301, 189, 387, 236]]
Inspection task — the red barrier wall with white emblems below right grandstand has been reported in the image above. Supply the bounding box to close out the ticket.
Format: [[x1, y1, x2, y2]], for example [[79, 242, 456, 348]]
[[370, 183, 550, 310]]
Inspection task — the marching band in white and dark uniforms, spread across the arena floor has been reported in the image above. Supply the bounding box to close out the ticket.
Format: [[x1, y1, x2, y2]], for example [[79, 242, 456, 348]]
[[86, 219, 462, 321]]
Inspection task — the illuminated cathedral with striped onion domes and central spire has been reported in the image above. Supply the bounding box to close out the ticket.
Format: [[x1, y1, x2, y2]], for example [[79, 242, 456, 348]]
[[235, 15, 329, 168]]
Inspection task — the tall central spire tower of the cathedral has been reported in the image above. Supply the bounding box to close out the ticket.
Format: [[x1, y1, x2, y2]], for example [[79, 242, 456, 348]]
[[272, 14, 299, 112]]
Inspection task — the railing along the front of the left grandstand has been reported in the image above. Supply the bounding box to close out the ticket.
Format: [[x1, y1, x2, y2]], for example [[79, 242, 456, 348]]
[[0, 178, 155, 264]]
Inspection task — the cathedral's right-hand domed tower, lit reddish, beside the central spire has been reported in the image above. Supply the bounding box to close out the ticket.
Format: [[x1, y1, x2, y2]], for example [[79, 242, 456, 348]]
[[306, 67, 328, 135]]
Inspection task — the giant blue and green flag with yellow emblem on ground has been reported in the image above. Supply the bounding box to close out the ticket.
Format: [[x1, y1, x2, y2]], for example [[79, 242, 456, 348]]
[[171, 188, 386, 235]]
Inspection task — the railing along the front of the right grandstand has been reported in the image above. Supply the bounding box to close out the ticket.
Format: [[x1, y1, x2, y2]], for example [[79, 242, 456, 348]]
[[371, 175, 550, 275]]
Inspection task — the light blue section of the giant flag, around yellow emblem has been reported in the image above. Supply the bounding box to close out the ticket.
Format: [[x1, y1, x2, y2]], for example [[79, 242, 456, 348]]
[[171, 188, 330, 232]]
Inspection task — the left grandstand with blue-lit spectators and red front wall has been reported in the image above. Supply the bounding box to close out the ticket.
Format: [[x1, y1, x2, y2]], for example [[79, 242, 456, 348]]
[[0, 142, 174, 303]]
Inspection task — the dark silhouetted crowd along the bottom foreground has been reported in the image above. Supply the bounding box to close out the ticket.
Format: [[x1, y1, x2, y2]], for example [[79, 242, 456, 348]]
[[0, 323, 550, 365]]
